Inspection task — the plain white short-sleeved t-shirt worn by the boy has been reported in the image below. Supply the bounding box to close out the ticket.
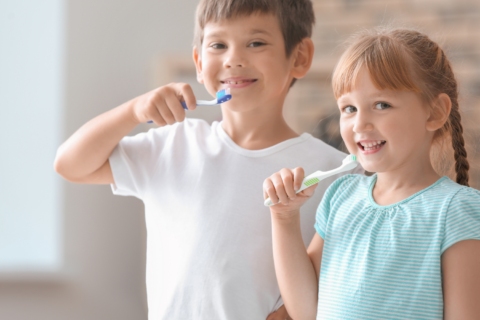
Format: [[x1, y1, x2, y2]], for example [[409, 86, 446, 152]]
[[110, 119, 356, 320]]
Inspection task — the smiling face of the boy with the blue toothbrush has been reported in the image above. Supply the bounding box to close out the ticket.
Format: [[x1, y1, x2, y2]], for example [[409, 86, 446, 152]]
[[194, 14, 295, 110]]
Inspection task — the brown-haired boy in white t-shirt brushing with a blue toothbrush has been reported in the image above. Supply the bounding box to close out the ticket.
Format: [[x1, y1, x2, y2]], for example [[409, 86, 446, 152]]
[[55, 0, 358, 320]]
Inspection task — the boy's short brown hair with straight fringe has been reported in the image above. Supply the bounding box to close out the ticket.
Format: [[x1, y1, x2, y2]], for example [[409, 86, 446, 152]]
[[194, 0, 315, 57]]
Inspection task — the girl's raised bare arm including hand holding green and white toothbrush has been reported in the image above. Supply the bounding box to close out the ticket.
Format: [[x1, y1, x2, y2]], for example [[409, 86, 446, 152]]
[[264, 168, 323, 320]]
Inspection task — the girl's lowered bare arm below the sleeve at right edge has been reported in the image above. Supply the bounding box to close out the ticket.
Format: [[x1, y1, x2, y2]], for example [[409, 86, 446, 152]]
[[442, 240, 480, 320]]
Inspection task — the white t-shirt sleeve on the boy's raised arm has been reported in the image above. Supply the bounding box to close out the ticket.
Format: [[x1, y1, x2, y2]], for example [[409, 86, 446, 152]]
[[109, 128, 166, 199]]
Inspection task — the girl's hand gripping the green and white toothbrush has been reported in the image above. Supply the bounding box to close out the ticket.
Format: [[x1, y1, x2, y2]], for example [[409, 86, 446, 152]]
[[263, 167, 317, 215]]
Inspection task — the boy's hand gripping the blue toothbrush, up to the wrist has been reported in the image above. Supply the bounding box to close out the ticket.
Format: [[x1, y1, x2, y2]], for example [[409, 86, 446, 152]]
[[132, 83, 196, 126]]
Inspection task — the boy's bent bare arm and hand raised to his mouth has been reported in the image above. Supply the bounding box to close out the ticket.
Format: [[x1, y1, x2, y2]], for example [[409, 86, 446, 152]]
[[54, 83, 196, 184]]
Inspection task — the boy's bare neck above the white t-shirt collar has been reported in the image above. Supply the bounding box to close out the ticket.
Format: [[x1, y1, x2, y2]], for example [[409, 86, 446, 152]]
[[222, 109, 298, 150]]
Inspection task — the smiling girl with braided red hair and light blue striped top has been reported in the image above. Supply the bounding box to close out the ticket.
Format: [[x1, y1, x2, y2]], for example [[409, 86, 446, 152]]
[[264, 29, 480, 320]]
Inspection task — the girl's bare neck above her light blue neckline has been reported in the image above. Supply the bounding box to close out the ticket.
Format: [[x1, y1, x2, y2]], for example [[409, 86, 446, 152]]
[[372, 162, 440, 205]]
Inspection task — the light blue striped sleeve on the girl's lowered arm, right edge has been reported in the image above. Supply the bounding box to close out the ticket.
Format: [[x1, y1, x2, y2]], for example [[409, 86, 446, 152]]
[[442, 188, 480, 253]]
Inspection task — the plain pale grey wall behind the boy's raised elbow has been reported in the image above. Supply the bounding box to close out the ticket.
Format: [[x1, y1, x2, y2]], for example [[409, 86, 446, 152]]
[[0, 0, 197, 320]]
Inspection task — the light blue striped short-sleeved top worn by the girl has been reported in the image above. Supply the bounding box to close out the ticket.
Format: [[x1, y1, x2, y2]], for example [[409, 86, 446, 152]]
[[315, 175, 480, 319]]
